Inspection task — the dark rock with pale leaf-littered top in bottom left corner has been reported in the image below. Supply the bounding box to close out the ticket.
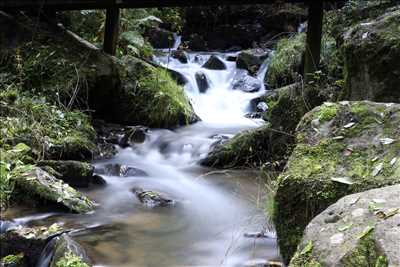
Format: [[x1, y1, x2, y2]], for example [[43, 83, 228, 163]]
[[0, 224, 64, 266]]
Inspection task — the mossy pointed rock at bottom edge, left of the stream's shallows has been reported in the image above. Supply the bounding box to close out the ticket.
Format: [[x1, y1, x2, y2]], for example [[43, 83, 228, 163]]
[[49, 234, 92, 267]]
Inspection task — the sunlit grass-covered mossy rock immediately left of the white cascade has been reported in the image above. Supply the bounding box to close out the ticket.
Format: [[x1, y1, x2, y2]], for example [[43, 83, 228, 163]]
[[108, 57, 198, 128]]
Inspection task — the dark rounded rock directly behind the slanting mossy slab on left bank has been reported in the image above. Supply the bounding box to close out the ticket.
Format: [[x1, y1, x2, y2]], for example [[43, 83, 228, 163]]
[[37, 160, 94, 187]]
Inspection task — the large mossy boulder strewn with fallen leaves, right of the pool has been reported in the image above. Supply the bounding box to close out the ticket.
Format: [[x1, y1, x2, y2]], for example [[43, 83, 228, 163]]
[[273, 101, 400, 261]]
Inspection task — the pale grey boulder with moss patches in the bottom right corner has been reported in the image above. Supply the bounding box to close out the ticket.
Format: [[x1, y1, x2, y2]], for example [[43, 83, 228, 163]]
[[289, 184, 400, 267]]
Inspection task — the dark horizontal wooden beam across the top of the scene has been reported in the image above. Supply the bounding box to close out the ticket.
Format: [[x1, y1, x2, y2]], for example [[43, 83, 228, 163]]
[[0, 0, 343, 11]]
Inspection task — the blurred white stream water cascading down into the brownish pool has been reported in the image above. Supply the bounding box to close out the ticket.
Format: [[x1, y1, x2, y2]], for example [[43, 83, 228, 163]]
[[2, 46, 279, 266]]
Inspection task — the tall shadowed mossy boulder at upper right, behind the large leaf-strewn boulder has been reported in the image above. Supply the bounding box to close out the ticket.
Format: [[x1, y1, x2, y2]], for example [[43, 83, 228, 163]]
[[343, 8, 400, 102]]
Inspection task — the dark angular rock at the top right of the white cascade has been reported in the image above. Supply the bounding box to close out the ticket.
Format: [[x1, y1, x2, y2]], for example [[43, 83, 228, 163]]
[[236, 49, 269, 75]]
